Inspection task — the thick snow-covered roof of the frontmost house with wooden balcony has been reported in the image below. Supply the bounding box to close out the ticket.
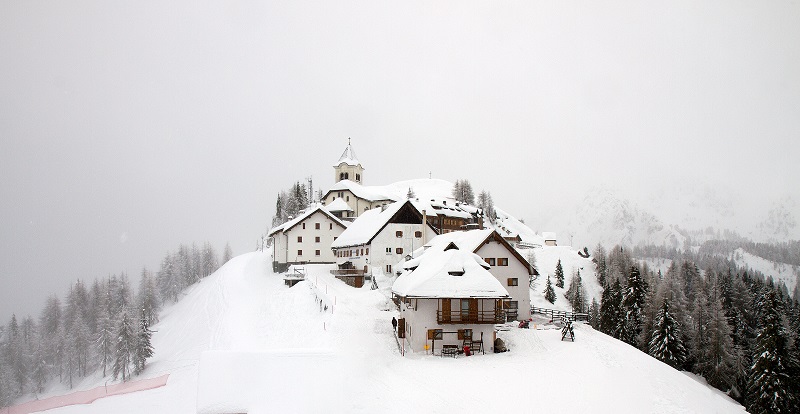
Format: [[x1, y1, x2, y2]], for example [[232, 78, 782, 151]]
[[392, 249, 508, 298]]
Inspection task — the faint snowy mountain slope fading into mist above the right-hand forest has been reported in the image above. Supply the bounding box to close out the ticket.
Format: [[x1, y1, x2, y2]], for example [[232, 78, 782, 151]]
[[543, 184, 800, 248]]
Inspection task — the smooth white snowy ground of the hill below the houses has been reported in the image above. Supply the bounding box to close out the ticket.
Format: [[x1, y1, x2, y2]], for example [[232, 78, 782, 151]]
[[42, 253, 744, 413]]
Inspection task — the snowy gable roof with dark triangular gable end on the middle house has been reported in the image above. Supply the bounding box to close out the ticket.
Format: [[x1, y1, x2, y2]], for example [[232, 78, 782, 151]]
[[331, 200, 436, 249]]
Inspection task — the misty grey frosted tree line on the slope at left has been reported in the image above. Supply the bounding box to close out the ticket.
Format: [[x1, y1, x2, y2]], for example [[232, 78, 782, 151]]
[[0, 243, 233, 407]]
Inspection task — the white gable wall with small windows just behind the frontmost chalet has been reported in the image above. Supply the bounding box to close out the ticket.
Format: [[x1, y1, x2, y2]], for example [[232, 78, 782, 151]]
[[477, 241, 531, 320]]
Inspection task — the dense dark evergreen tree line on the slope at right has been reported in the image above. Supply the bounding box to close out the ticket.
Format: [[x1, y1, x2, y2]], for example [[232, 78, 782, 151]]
[[573, 246, 800, 413]]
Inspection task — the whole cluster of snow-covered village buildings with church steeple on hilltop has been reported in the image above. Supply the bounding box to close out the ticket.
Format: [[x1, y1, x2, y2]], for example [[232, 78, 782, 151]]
[[268, 142, 572, 354]]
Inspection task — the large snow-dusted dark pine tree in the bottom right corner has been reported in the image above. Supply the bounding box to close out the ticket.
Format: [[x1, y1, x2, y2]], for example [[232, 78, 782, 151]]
[[747, 289, 795, 414]]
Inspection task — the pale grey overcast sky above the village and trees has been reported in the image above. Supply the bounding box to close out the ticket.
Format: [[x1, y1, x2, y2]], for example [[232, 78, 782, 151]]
[[0, 0, 800, 323]]
